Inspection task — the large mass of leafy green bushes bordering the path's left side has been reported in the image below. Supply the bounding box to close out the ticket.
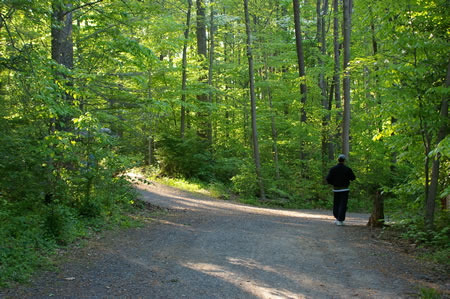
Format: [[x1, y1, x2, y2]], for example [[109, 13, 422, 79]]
[[0, 113, 140, 285]]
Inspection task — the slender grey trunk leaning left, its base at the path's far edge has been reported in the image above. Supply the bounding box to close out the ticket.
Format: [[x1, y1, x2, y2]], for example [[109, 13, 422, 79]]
[[244, 0, 266, 200]]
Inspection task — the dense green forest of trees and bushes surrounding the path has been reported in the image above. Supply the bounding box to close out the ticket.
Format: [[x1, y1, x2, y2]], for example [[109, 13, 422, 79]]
[[0, 0, 450, 286]]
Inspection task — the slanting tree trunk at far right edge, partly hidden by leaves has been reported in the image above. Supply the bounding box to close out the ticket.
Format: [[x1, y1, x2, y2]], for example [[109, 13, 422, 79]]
[[425, 62, 450, 228]]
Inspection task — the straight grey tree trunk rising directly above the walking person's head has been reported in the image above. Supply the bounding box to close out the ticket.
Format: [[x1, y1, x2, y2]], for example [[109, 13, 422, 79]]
[[342, 0, 352, 157]]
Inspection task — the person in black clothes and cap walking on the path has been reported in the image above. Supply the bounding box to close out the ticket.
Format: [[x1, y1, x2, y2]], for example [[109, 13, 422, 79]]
[[327, 154, 356, 226]]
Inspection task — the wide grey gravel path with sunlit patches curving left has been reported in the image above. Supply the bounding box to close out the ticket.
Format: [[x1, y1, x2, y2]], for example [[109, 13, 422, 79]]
[[0, 179, 450, 298]]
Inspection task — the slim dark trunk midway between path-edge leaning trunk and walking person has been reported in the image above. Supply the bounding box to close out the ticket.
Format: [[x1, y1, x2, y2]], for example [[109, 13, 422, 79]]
[[292, 0, 307, 160]]
